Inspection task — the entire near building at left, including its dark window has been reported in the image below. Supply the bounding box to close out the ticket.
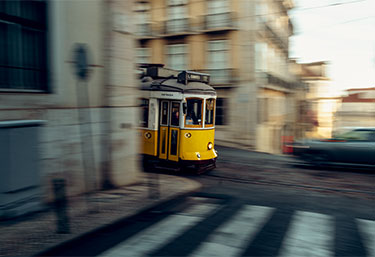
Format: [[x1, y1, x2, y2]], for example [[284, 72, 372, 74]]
[[0, 0, 139, 215]]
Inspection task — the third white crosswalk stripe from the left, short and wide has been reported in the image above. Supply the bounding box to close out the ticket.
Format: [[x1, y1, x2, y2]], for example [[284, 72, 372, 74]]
[[279, 211, 334, 257]]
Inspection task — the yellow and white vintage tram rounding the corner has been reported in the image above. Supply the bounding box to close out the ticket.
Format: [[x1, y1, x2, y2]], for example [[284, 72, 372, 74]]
[[141, 66, 217, 172]]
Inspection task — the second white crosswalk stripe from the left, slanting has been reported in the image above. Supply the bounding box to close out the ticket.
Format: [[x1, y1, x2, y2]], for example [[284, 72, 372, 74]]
[[191, 205, 274, 257]]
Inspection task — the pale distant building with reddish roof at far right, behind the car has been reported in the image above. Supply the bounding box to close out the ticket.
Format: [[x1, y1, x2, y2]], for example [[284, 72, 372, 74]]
[[334, 87, 375, 133]]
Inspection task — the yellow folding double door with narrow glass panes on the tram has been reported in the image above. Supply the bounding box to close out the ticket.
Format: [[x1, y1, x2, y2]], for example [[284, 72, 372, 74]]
[[159, 100, 181, 161]]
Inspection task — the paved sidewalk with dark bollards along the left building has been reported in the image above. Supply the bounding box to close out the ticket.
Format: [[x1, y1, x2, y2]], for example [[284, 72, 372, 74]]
[[0, 174, 201, 256]]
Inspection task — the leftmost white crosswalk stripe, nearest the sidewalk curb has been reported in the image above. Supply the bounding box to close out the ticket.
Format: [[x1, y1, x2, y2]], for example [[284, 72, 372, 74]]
[[100, 203, 219, 257]]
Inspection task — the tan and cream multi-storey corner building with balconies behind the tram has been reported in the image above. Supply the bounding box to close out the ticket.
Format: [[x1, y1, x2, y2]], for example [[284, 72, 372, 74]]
[[134, 0, 301, 153]]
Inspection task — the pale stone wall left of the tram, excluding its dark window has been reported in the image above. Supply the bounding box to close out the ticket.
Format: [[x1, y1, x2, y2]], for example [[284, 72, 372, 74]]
[[0, 0, 140, 204]]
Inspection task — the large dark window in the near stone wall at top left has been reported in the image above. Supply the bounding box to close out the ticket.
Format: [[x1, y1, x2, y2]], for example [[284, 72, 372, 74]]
[[0, 0, 47, 91]]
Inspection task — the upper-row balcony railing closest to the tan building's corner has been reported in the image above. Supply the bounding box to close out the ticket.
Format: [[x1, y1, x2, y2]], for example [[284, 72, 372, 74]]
[[203, 12, 237, 30]]
